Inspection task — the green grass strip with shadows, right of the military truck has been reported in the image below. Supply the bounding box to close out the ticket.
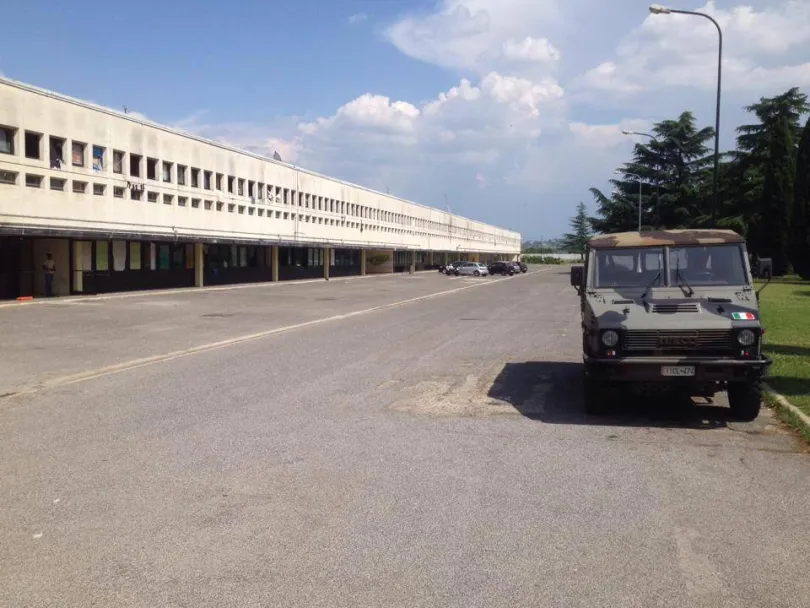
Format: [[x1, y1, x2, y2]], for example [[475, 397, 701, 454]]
[[758, 277, 810, 414]]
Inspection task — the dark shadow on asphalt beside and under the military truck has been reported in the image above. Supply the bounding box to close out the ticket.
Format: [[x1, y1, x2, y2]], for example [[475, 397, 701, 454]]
[[488, 361, 732, 429]]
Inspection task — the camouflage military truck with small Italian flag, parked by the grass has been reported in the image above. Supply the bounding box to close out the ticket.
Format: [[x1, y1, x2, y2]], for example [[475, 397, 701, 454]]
[[571, 230, 771, 420]]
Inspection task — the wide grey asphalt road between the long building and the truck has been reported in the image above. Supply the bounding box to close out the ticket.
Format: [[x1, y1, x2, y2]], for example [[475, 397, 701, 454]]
[[0, 268, 810, 608]]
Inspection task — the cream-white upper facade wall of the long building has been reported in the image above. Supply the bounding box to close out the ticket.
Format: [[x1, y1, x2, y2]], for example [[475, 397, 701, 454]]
[[0, 79, 521, 253]]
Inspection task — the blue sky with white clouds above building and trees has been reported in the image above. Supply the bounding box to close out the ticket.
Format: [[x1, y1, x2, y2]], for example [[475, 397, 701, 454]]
[[0, 0, 810, 239]]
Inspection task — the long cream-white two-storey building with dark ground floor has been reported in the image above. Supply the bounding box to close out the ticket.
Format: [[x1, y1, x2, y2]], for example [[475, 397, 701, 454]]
[[0, 78, 521, 298]]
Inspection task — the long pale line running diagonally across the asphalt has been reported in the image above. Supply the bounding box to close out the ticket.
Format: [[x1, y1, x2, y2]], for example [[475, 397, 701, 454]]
[[4, 268, 550, 400]]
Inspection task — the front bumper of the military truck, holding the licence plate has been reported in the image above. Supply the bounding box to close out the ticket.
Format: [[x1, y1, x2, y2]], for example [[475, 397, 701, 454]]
[[583, 355, 772, 383]]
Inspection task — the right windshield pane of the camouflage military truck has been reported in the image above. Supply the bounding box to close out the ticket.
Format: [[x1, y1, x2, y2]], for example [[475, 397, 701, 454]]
[[669, 245, 748, 287]]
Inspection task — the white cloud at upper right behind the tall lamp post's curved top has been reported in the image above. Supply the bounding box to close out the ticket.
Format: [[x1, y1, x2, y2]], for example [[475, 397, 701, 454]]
[[572, 0, 810, 97]]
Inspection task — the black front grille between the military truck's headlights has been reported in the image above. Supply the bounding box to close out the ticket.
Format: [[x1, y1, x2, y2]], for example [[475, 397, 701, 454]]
[[623, 329, 732, 355]]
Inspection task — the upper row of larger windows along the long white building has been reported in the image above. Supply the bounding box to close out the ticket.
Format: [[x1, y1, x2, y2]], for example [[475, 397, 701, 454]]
[[0, 125, 517, 242]]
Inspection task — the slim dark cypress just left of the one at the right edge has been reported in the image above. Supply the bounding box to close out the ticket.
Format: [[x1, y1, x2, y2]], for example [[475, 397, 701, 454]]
[[757, 117, 796, 276]]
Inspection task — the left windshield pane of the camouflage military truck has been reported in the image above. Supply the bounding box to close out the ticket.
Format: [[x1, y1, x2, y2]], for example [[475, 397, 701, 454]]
[[594, 247, 664, 289]]
